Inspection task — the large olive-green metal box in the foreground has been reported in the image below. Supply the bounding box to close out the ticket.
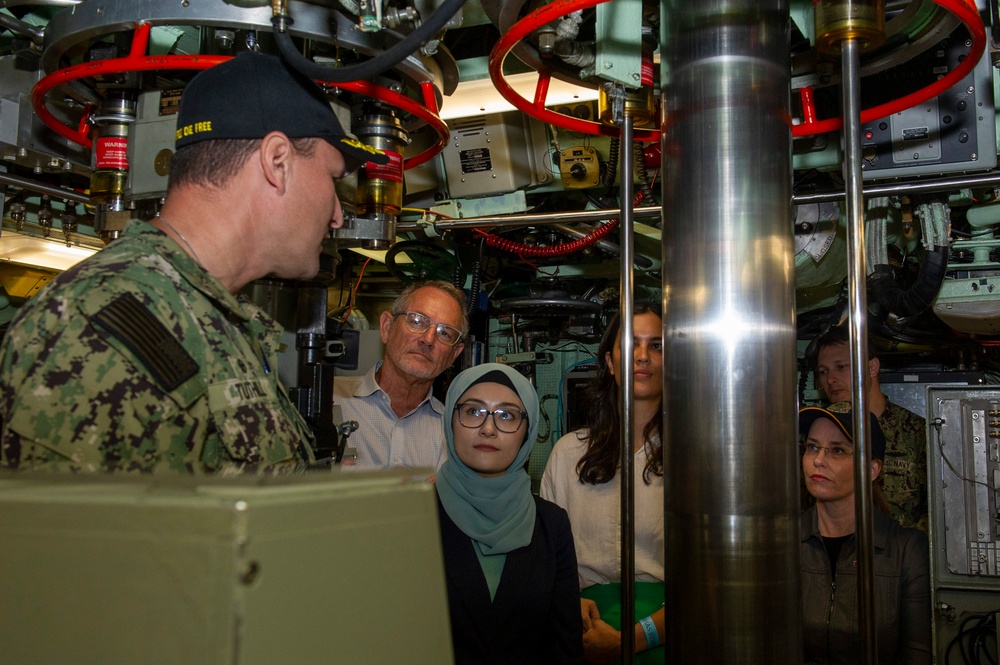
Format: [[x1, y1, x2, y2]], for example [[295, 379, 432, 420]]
[[0, 470, 453, 665]]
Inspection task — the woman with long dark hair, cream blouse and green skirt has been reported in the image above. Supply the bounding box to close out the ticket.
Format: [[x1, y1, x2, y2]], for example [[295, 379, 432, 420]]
[[541, 302, 665, 663]]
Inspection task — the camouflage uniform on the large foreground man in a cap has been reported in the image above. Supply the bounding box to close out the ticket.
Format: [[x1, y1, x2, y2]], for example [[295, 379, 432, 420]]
[[0, 220, 313, 474]]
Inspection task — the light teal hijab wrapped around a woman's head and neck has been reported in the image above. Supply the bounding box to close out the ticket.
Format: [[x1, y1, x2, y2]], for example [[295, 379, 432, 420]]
[[435, 363, 539, 555]]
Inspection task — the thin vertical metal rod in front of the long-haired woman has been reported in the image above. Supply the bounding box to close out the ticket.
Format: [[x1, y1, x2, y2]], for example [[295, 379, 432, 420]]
[[618, 112, 635, 665]]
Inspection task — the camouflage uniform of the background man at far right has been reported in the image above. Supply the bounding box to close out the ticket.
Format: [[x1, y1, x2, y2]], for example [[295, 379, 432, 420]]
[[878, 395, 928, 533]]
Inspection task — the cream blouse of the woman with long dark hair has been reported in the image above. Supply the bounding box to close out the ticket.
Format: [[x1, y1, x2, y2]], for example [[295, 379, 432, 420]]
[[540, 429, 664, 589]]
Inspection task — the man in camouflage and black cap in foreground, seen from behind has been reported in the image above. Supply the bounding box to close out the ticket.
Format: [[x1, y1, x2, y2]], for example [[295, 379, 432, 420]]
[[0, 53, 386, 473]]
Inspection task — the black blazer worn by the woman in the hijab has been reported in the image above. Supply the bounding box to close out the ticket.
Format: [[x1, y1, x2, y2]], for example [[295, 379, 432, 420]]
[[438, 497, 584, 665]]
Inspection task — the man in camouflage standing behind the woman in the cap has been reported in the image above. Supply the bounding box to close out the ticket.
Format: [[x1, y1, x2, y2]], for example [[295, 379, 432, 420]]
[[815, 327, 928, 533]]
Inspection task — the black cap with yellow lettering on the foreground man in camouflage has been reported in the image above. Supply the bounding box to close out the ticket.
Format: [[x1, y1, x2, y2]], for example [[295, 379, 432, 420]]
[[175, 51, 389, 172]]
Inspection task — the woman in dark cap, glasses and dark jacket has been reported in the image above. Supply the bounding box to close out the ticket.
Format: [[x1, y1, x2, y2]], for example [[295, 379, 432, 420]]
[[799, 402, 931, 665]]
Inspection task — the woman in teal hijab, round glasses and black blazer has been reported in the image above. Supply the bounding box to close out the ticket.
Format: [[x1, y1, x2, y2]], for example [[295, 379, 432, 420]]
[[435, 364, 583, 665]]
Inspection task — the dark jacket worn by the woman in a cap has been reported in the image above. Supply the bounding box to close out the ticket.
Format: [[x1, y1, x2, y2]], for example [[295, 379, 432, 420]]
[[799, 506, 931, 665]]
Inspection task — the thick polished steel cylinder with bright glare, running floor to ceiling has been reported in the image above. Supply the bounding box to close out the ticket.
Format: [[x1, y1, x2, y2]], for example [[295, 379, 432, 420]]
[[661, 0, 802, 665]]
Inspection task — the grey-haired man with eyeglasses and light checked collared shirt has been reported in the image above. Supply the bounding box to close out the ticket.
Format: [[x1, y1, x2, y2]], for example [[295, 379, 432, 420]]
[[334, 280, 469, 470]]
